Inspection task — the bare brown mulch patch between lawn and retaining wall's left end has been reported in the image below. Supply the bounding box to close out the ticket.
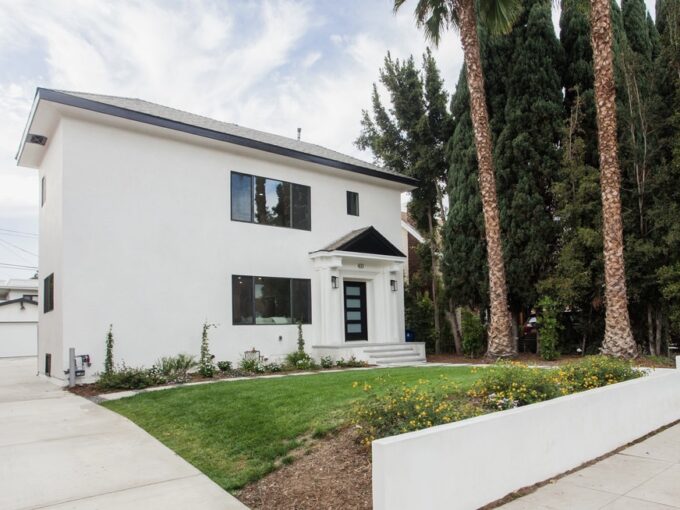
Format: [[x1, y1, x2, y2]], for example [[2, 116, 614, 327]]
[[236, 428, 372, 510]]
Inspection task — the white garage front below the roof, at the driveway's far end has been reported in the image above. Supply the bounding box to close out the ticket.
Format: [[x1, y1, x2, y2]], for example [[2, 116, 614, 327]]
[[0, 303, 38, 358]]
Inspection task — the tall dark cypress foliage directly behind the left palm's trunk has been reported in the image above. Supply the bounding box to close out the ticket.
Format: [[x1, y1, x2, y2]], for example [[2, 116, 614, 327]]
[[444, 0, 563, 344]]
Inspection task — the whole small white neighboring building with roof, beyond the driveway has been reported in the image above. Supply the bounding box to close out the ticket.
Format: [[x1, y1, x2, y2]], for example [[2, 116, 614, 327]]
[[0, 279, 38, 358]]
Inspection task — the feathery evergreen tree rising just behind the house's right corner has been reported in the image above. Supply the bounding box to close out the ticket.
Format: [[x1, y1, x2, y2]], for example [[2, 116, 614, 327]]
[[356, 53, 452, 353]]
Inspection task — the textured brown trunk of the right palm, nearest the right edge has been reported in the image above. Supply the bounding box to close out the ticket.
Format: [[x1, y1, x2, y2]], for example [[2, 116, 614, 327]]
[[590, 0, 637, 358]]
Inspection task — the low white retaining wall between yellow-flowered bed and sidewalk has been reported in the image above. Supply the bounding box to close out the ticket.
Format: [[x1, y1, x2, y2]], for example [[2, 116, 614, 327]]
[[373, 357, 680, 510]]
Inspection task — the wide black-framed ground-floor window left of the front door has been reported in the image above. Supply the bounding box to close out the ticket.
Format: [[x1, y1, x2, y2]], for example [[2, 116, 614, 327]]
[[231, 275, 312, 325]]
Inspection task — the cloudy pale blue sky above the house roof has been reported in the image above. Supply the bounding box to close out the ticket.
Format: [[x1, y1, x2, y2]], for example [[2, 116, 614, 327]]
[[0, 0, 653, 280]]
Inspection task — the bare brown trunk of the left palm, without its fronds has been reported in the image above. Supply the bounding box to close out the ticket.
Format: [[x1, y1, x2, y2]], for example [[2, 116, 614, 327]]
[[456, 0, 517, 357]]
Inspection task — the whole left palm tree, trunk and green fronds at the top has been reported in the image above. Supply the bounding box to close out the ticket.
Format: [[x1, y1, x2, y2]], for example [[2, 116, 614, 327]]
[[394, 0, 521, 357]]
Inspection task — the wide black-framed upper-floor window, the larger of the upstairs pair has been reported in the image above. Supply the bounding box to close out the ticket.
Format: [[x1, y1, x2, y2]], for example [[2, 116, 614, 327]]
[[231, 172, 312, 230]]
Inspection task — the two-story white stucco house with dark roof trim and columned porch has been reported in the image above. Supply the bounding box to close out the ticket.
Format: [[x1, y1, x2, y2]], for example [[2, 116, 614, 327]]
[[17, 89, 424, 378]]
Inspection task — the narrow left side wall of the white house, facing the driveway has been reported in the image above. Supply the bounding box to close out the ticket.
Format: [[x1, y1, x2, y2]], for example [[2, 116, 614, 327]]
[[38, 119, 68, 377]]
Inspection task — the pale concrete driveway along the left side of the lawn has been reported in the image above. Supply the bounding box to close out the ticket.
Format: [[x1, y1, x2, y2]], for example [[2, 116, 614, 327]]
[[0, 358, 247, 510]]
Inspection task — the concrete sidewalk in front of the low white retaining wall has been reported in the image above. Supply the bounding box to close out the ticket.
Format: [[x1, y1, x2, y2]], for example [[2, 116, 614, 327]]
[[501, 424, 680, 510]]
